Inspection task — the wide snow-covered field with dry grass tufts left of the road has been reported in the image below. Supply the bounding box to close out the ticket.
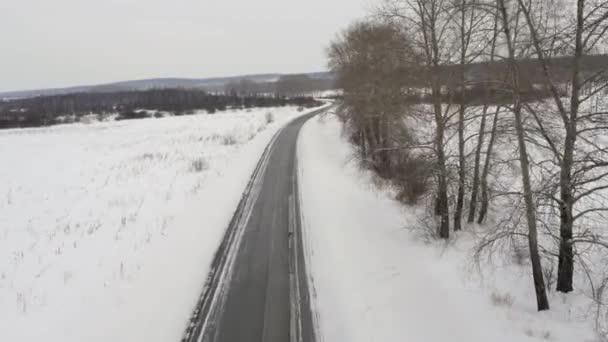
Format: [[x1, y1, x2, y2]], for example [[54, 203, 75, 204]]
[[0, 107, 324, 342]]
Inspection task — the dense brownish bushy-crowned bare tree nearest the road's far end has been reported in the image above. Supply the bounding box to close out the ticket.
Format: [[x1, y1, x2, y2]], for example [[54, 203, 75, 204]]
[[328, 21, 416, 172]]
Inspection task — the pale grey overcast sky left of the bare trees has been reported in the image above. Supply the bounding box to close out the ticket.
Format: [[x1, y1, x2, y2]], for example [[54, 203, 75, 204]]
[[0, 0, 370, 91]]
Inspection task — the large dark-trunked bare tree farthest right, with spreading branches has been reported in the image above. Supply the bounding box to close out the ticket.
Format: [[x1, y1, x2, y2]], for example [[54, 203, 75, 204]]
[[518, 0, 608, 293]]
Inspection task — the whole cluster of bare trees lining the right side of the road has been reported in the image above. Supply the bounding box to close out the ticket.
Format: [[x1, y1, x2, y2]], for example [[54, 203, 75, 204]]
[[328, 0, 608, 316]]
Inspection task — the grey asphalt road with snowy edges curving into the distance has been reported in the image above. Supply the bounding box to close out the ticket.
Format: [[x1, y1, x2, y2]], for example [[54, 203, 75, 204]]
[[183, 110, 323, 342]]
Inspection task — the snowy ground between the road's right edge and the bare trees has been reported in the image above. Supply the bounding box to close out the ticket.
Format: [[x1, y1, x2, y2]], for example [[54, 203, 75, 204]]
[[298, 116, 595, 342]]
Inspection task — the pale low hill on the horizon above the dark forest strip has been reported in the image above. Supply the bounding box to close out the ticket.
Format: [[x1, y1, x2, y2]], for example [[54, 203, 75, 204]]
[[0, 72, 334, 99]]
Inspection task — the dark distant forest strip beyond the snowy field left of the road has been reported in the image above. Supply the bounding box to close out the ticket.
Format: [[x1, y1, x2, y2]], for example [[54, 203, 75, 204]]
[[0, 89, 319, 129]]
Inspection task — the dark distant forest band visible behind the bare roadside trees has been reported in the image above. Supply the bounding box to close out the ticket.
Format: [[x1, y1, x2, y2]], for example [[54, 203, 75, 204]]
[[336, 54, 608, 105]]
